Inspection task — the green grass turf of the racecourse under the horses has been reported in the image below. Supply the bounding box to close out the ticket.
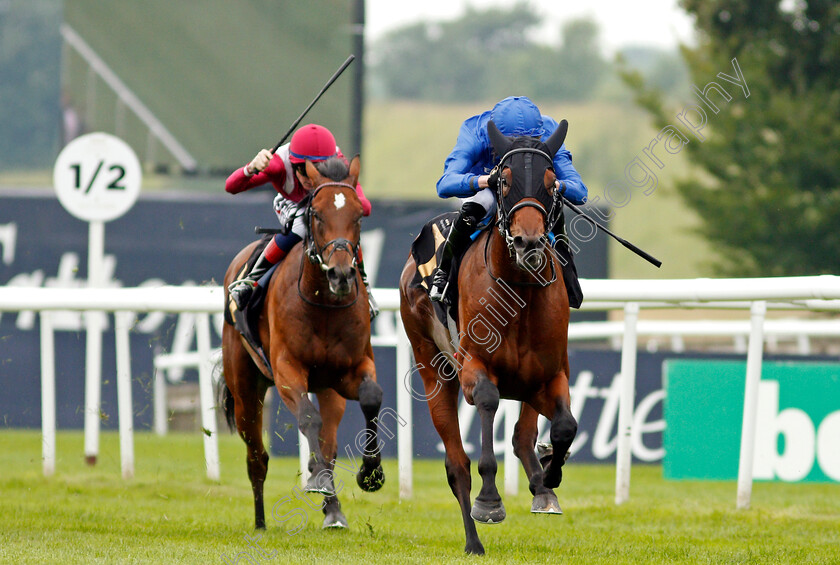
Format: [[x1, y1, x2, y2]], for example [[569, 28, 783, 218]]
[[0, 430, 840, 564]]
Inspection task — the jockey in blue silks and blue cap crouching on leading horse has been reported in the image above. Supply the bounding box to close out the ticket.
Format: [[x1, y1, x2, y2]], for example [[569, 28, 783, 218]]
[[429, 96, 588, 308]]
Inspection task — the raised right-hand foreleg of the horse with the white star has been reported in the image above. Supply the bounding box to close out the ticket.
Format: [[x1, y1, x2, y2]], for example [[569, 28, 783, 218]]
[[356, 357, 385, 492]]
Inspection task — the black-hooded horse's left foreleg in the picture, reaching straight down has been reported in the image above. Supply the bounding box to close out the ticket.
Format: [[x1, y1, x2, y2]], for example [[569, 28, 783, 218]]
[[461, 357, 506, 524]]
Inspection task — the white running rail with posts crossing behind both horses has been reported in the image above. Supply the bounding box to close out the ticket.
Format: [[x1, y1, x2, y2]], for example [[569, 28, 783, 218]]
[[0, 275, 840, 508]]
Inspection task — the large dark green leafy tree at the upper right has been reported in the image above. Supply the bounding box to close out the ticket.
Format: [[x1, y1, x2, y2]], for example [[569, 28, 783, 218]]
[[624, 0, 840, 276]]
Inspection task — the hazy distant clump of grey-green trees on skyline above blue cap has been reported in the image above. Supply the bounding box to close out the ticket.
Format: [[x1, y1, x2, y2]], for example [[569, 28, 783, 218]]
[[372, 1, 608, 102]]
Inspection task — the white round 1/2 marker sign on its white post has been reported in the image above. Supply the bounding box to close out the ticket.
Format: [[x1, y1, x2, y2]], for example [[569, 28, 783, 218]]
[[53, 132, 142, 465]]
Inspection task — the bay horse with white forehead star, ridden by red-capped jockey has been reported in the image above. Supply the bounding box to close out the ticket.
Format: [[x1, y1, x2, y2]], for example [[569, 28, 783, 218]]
[[220, 156, 384, 529]]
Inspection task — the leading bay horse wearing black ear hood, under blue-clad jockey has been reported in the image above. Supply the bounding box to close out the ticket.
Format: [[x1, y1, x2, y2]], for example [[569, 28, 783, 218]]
[[400, 120, 577, 554]]
